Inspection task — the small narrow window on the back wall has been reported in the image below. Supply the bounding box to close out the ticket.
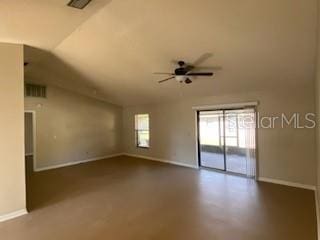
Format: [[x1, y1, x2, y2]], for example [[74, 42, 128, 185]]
[[135, 114, 150, 148]]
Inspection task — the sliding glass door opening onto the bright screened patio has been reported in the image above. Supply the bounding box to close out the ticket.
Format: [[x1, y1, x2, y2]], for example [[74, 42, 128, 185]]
[[197, 108, 256, 178]]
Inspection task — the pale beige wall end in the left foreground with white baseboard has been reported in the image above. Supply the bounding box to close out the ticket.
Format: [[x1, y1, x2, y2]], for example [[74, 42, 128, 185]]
[[0, 44, 26, 217]]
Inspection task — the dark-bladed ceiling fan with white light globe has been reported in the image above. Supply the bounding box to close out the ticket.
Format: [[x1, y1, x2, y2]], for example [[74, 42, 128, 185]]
[[154, 61, 214, 84]]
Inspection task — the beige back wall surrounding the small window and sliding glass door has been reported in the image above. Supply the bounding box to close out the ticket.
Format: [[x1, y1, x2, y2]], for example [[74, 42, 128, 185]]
[[123, 87, 316, 185]]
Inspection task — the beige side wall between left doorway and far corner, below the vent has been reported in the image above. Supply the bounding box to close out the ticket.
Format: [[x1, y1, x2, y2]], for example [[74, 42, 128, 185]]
[[25, 86, 122, 168]]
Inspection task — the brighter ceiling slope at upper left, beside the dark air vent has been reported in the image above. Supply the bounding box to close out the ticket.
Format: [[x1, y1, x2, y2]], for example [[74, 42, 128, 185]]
[[0, 0, 111, 50]]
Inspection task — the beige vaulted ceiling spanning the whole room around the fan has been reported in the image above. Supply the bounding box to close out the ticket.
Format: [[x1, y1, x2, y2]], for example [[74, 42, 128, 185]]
[[0, 0, 317, 105]]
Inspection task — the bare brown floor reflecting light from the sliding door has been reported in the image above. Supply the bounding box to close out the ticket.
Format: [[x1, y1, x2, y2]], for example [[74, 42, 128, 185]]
[[0, 156, 316, 240]]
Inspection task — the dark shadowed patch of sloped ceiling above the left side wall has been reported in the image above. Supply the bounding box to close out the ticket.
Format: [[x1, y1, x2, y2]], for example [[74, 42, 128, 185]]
[[24, 45, 111, 102]]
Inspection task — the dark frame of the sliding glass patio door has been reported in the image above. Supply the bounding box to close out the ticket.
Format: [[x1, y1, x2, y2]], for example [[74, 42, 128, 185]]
[[196, 106, 258, 179]]
